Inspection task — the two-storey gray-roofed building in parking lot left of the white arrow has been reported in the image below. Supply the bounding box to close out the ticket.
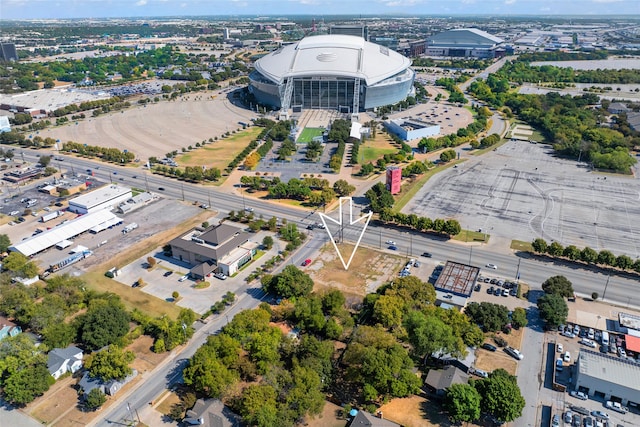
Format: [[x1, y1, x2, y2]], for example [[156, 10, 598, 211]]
[[169, 223, 258, 279]]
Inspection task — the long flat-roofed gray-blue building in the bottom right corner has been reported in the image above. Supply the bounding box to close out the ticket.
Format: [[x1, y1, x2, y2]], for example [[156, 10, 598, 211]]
[[576, 349, 640, 406]]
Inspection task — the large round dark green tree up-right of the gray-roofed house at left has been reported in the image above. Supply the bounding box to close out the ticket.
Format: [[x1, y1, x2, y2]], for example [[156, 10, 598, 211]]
[[77, 297, 129, 350]]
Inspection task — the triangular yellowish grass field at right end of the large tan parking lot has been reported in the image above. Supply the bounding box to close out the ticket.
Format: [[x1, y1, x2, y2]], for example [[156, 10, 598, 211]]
[[176, 126, 262, 170]]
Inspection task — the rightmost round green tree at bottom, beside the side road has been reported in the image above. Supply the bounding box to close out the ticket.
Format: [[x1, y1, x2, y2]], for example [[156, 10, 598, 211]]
[[473, 368, 526, 422]]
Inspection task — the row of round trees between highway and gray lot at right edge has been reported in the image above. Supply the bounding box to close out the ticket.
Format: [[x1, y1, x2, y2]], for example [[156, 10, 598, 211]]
[[531, 238, 640, 273]]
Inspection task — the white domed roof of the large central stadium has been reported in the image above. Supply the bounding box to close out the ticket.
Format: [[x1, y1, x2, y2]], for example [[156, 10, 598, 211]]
[[255, 35, 411, 86]]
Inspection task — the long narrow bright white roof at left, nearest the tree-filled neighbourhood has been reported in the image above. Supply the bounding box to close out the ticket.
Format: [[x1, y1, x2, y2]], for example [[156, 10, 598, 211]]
[[9, 210, 116, 256]]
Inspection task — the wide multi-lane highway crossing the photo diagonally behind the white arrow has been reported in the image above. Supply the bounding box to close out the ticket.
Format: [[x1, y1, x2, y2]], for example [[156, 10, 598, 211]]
[[16, 150, 640, 307]]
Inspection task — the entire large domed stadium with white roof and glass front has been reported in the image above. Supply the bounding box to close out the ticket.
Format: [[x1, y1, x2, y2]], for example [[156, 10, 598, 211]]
[[249, 35, 415, 113]]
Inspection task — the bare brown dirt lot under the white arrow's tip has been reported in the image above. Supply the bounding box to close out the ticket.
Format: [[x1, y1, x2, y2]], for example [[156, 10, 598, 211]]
[[309, 244, 402, 297]]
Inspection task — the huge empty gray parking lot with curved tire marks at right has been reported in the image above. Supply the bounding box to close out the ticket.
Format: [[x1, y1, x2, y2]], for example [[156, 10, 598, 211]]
[[402, 141, 640, 258]]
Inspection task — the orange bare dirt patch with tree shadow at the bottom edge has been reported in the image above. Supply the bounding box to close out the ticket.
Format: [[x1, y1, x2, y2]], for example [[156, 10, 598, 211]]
[[379, 396, 451, 427]]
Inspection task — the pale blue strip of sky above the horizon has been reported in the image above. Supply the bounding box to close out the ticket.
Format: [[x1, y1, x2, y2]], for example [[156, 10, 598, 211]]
[[0, 0, 640, 19]]
